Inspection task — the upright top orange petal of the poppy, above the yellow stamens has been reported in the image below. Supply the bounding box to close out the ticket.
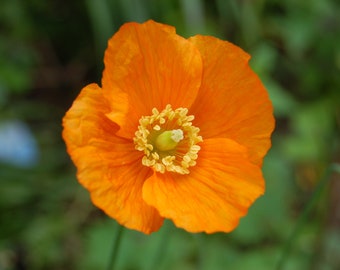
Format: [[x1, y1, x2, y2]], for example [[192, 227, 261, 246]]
[[102, 21, 202, 138]]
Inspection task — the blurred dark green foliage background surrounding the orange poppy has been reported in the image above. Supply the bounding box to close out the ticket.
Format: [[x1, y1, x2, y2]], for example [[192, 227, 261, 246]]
[[0, 0, 340, 270]]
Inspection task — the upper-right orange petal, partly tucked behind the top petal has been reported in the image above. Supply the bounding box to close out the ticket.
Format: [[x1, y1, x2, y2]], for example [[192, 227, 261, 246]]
[[189, 36, 274, 165]]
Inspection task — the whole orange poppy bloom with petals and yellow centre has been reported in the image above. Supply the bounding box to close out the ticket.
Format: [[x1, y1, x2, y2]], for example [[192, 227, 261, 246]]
[[63, 21, 274, 233]]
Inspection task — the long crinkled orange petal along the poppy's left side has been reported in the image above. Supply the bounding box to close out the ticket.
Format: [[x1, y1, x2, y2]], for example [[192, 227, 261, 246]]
[[63, 84, 163, 233]]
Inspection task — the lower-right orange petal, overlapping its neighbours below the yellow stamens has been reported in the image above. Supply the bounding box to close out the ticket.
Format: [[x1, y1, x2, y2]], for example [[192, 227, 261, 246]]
[[143, 138, 264, 233]]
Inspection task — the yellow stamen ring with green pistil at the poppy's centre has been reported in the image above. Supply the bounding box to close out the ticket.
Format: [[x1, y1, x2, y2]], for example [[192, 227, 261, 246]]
[[133, 105, 203, 174]]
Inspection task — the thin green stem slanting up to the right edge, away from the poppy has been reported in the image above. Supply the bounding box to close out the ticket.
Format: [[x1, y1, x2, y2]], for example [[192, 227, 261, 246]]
[[276, 164, 340, 270]]
